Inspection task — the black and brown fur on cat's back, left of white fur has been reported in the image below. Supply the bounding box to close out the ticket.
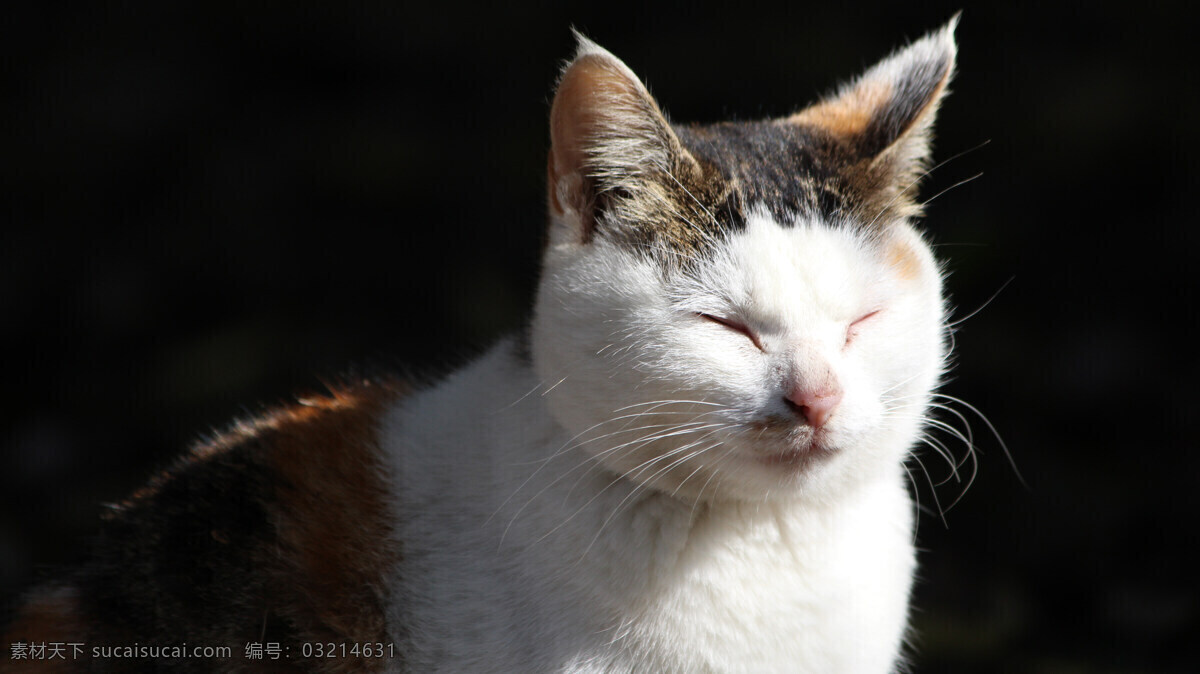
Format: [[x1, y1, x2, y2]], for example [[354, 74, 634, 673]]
[[4, 383, 404, 672]]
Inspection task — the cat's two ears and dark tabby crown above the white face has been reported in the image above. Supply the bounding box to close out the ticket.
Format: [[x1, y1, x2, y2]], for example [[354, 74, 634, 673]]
[[547, 17, 958, 267]]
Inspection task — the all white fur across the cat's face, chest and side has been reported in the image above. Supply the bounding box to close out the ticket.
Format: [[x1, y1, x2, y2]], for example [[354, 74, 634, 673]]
[[384, 206, 944, 674]]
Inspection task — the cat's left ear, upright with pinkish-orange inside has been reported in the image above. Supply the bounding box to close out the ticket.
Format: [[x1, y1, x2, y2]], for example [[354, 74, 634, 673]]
[[547, 32, 690, 242]]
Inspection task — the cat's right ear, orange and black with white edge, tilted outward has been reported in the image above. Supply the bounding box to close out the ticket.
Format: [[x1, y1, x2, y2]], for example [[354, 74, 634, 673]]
[[787, 14, 959, 199]]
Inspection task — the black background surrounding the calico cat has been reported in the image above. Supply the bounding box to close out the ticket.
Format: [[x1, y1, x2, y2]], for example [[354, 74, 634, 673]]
[[0, 2, 1200, 673]]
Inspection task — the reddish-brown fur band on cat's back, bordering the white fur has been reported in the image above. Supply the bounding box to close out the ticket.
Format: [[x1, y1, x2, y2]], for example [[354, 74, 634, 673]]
[[255, 383, 400, 672]]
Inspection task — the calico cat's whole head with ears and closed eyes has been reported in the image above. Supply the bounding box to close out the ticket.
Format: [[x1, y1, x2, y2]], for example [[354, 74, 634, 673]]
[[532, 20, 955, 499]]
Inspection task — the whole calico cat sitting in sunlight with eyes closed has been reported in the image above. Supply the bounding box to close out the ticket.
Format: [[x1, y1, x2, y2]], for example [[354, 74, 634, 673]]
[[5, 18, 956, 673]]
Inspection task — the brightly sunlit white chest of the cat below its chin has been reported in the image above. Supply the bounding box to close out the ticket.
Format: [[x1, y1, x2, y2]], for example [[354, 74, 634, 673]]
[[571, 501, 911, 673]]
